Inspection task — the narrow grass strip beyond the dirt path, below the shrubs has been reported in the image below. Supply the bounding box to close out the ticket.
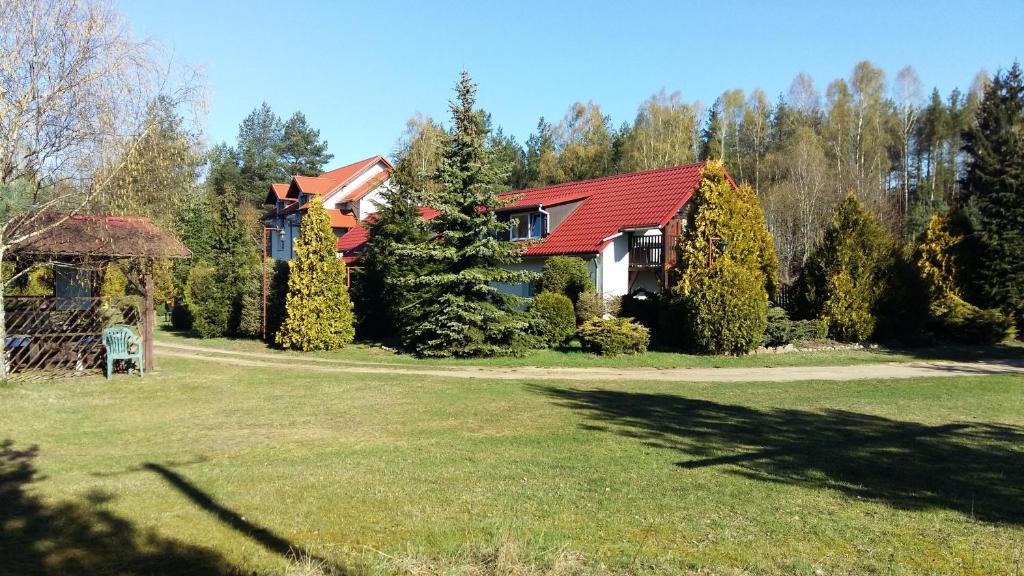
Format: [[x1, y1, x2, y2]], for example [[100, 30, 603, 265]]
[[157, 329, 1024, 368]]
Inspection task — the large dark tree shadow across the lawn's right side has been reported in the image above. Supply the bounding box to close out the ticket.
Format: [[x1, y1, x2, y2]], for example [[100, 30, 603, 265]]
[[538, 386, 1024, 525]]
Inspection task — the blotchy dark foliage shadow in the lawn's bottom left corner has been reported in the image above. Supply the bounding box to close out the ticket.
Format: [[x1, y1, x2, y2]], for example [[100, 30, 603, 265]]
[[0, 440, 238, 575]]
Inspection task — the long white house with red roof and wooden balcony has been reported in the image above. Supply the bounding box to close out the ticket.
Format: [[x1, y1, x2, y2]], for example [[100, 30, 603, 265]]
[[338, 163, 716, 297]]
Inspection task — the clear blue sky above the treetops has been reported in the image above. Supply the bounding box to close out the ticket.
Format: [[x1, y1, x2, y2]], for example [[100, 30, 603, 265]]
[[118, 0, 1024, 165]]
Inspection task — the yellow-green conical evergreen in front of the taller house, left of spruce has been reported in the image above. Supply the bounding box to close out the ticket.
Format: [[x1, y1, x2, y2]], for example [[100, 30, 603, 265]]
[[278, 202, 355, 351]]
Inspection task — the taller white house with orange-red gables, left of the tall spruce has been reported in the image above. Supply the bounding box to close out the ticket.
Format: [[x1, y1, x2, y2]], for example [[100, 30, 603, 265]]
[[265, 156, 394, 260]]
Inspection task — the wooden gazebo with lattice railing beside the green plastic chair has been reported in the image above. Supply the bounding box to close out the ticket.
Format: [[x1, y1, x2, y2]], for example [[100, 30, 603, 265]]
[[4, 214, 191, 372]]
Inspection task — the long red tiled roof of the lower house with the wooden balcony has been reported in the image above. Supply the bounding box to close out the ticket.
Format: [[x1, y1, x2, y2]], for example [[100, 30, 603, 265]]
[[503, 163, 703, 256]]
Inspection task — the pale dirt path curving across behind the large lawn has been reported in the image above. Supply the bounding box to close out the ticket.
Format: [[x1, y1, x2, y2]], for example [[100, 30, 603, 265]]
[[155, 341, 1024, 382]]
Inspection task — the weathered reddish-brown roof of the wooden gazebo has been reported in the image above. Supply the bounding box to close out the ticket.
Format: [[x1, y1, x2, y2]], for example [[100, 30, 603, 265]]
[[11, 214, 191, 258]]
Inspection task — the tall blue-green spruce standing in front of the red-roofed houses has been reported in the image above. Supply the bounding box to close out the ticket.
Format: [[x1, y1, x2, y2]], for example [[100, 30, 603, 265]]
[[398, 71, 535, 357]]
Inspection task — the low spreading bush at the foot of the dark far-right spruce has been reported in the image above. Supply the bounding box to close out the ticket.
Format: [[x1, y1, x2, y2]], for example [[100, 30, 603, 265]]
[[929, 295, 1017, 344]]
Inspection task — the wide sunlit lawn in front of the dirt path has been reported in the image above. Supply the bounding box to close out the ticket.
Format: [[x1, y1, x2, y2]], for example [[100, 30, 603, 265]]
[[0, 351, 1024, 575]]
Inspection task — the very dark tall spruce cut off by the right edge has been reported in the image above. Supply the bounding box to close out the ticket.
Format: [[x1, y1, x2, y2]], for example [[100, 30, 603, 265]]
[[964, 64, 1024, 326]]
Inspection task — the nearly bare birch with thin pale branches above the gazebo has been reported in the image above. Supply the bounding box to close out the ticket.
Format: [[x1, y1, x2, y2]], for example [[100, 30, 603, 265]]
[[0, 0, 199, 377]]
